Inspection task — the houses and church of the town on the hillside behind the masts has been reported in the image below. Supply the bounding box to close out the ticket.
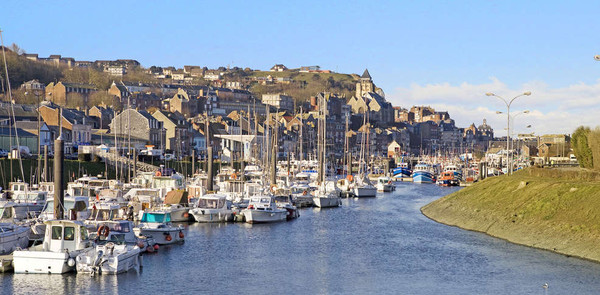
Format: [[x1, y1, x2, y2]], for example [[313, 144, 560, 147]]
[[0, 53, 571, 170]]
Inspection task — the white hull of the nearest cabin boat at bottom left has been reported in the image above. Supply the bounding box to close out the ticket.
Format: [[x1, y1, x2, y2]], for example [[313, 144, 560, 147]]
[[13, 251, 79, 274]]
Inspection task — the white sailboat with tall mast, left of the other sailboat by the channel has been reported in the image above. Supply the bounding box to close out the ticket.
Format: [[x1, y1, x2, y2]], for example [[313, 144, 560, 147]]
[[313, 95, 342, 208]]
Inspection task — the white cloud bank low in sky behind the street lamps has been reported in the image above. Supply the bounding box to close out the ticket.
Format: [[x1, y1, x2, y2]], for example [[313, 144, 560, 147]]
[[387, 77, 600, 136]]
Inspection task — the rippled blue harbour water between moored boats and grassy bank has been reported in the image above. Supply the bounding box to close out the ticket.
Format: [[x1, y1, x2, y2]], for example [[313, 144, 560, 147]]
[[0, 183, 600, 294]]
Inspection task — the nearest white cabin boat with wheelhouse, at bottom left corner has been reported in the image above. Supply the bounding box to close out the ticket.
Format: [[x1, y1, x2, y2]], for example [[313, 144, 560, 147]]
[[13, 220, 93, 274]]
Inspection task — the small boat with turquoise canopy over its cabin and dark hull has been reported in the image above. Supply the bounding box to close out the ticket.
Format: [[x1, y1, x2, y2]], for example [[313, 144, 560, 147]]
[[134, 211, 185, 245]]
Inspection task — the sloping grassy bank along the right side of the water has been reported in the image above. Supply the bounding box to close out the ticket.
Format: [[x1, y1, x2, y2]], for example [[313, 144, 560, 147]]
[[421, 168, 600, 262]]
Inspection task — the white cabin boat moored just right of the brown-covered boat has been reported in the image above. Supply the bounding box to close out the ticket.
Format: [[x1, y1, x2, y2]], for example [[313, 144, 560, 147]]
[[190, 194, 233, 223]]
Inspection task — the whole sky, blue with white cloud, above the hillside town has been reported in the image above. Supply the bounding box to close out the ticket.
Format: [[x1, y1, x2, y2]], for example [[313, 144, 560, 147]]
[[0, 0, 600, 136]]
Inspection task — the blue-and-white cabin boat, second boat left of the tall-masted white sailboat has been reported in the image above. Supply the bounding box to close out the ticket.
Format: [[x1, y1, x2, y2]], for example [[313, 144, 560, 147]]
[[242, 195, 288, 223]]
